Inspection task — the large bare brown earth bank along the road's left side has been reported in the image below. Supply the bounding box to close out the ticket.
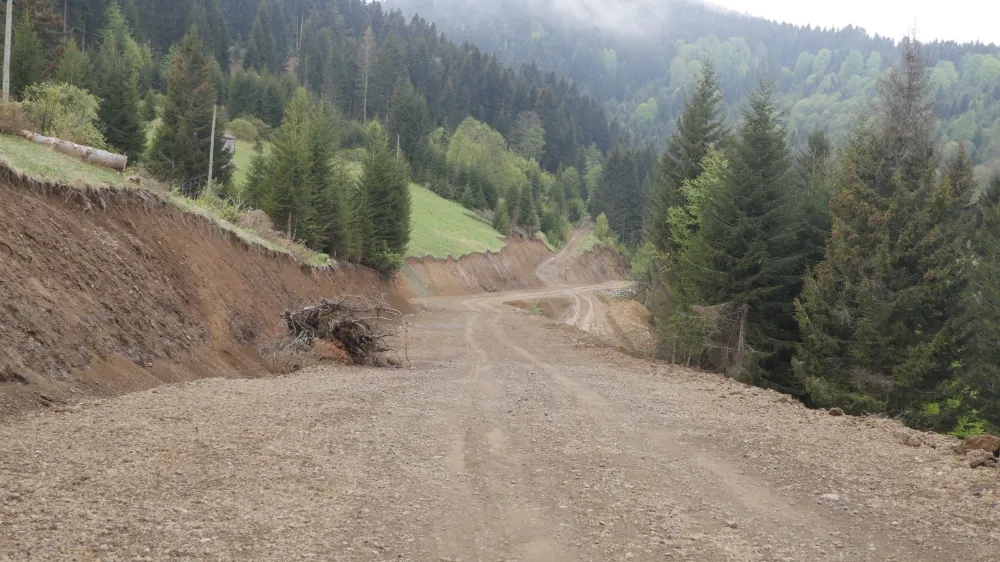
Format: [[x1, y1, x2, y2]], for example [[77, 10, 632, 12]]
[[0, 173, 392, 416]]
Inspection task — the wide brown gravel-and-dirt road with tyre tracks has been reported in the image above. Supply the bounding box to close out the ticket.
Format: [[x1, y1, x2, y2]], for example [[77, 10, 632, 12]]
[[0, 255, 1000, 561]]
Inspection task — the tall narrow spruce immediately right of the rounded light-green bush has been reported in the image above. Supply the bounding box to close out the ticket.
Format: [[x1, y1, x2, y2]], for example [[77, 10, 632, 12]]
[[93, 4, 146, 161]]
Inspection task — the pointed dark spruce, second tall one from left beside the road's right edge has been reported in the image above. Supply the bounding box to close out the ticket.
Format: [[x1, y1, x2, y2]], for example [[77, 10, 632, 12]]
[[679, 77, 805, 384]]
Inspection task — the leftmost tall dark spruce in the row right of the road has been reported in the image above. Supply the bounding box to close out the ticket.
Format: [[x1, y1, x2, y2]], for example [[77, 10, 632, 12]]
[[649, 60, 726, 252]]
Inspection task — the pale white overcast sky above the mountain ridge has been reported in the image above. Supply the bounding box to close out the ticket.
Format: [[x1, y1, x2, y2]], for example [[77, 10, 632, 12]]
[[708, 0, 1000, 44]]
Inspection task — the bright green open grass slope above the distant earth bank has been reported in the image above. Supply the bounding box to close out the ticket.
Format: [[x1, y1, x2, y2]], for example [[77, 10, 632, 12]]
[[406, 184, 503, 258]]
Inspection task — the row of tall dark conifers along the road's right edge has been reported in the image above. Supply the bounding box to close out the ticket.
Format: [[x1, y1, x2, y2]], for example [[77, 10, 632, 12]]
[[624, 40, 1000, 434]]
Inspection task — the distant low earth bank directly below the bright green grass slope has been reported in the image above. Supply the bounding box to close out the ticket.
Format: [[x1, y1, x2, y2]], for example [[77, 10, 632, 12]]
[[397, 237, 551, 297]]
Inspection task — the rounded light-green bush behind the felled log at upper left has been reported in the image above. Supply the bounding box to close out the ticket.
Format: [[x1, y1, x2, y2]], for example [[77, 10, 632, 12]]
[[21, 82, 106, 148]]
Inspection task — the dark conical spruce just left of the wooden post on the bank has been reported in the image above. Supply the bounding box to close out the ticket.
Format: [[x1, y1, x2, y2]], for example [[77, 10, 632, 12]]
[[148, 29, 232, 197]]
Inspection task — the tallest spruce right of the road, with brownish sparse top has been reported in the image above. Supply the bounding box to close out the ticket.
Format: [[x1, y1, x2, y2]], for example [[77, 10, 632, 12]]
[[795, 40, 974, 428]]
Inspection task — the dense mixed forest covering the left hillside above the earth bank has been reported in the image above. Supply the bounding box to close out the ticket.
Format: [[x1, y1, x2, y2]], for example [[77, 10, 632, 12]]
[[1, 0, 615, 270]]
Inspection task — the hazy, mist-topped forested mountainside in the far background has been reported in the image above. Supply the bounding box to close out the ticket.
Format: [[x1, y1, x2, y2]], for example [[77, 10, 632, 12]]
[[388, 0, 1000, 179]]
